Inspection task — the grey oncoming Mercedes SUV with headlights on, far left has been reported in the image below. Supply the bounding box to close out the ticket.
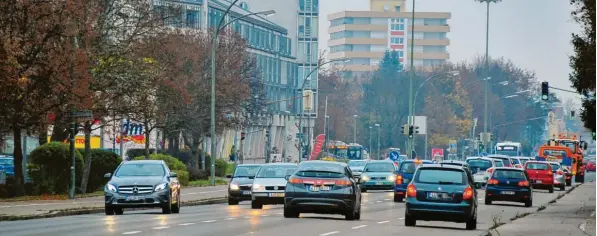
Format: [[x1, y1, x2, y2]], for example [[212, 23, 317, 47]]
[[104, 160, 180, 215]]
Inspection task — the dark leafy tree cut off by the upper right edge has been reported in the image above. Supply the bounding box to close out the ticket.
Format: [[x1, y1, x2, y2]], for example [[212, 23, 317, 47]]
[[570, 0, 595, 132]]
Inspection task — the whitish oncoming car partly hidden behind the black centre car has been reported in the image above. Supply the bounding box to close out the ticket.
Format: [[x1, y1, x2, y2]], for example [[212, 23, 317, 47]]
[[251, 163, 297, 209]]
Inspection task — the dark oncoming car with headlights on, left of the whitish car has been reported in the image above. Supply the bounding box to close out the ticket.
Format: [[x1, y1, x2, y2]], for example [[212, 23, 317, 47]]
[[226, 164, 261, 205]]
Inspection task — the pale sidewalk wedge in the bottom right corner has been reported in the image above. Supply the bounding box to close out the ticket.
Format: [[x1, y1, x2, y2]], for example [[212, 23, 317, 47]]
[[491, 182, 596, 236]]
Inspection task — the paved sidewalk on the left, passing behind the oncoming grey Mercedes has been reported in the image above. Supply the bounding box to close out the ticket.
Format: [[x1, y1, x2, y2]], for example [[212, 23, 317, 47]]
[[0, 185, 228, 218]]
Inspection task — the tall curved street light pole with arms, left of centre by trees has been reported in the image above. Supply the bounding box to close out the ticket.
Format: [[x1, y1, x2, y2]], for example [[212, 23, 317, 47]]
[[209, 0, 276, 186]]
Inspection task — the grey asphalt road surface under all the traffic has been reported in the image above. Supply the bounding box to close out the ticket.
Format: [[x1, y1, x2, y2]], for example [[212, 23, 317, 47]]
[[0, 173, 595, 236]]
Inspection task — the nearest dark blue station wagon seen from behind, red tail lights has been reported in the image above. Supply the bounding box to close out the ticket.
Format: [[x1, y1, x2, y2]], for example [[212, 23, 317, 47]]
[[404, 164, 477, 230]]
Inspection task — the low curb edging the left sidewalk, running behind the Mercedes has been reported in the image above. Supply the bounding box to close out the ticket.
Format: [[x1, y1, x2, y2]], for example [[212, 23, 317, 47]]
[[0, 197, 228, 221]]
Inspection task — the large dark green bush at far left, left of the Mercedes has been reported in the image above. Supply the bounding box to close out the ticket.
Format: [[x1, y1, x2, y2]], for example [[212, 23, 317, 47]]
[[28, 142, 83, 194]]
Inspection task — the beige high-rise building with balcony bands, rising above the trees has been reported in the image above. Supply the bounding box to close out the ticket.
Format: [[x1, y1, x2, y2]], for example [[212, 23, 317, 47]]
[[327, 0, 451, 78]]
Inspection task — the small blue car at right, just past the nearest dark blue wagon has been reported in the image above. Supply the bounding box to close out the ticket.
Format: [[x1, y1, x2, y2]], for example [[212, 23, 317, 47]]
[[485, 167, 533, 207]]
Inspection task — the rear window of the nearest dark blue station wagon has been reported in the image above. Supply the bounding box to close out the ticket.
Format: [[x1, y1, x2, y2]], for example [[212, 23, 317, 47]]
[[415, 169, 467, 185]]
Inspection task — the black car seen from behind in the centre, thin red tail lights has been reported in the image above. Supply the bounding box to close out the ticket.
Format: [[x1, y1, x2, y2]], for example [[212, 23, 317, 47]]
[[284, 161, 361, 220]]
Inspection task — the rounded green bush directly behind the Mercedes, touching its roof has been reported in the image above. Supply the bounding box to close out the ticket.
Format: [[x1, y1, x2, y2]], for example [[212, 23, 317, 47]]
[[79, 149, 122, 192]]
